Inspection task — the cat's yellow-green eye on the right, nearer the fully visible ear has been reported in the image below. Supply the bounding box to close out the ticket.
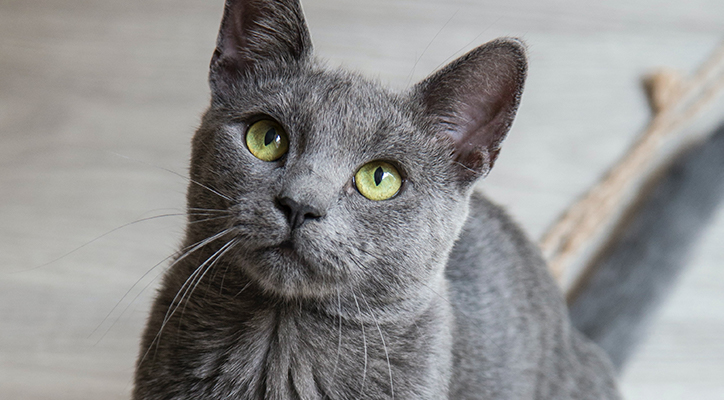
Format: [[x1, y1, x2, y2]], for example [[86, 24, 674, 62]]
[[354, 161, 402, 201]]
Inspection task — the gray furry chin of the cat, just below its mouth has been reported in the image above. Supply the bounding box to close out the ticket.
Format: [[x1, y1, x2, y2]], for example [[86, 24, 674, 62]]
[[236, 239, 341, 298]]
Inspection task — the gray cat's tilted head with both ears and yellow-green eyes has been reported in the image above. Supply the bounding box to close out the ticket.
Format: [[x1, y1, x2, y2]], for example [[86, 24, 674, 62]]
[[188, 0, 526, 298]]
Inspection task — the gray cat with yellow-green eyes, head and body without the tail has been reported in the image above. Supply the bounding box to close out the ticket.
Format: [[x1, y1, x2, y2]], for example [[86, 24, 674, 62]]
[[134, 0, 724, 400]]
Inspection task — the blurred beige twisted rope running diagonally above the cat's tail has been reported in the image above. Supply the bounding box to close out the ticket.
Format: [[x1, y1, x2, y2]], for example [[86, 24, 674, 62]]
[[539, 43, 724, 283]]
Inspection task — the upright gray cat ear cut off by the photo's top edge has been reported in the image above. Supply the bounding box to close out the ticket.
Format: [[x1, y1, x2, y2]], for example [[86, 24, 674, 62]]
[[209, 0, 312, 95]]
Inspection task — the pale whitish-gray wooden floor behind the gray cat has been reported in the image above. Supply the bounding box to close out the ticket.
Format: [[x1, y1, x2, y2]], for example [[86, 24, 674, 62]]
[[0, 0, 724, 400]]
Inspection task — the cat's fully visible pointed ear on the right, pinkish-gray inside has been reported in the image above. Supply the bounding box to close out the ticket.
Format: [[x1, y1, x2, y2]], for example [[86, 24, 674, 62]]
[[414, 38, 527, 182]]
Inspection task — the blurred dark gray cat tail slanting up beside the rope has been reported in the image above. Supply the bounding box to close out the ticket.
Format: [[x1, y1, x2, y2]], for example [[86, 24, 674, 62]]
[[570, 126, 724, 369]]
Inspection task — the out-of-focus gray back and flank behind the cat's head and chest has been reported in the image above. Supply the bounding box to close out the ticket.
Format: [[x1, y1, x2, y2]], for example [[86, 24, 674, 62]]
[[447, 196, 618, 399]]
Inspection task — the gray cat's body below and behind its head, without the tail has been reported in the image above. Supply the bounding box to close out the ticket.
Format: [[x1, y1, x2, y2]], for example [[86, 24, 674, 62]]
[[137, 194, 617, 399]]
